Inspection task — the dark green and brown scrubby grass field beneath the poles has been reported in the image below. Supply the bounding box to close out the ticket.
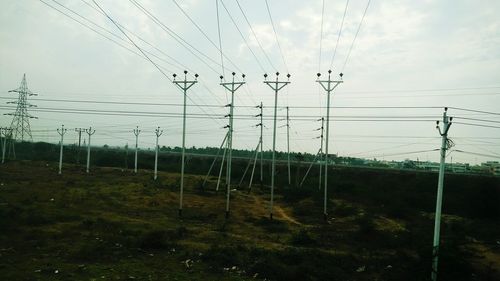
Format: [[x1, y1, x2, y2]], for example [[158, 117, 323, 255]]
[[0, 161, 500, 280]]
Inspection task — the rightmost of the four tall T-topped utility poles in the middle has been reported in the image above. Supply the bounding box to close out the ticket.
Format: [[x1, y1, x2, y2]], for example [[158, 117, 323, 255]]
[[316, 70, 344, 221]]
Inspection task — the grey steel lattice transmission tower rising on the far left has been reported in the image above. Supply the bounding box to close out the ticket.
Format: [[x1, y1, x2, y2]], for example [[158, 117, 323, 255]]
[[5, 74, 37, 141]]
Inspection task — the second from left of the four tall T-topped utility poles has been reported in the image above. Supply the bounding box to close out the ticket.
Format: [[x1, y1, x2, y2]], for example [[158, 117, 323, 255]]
[[220, 72, 245, 218]]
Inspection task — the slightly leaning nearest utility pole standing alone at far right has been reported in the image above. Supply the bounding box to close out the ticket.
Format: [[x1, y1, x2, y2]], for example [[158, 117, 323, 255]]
[[431, 107, 453, 281]]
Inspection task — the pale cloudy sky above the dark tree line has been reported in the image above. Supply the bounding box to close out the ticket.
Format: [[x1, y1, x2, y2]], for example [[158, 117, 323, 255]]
[[0, 0, 500, 164]]
